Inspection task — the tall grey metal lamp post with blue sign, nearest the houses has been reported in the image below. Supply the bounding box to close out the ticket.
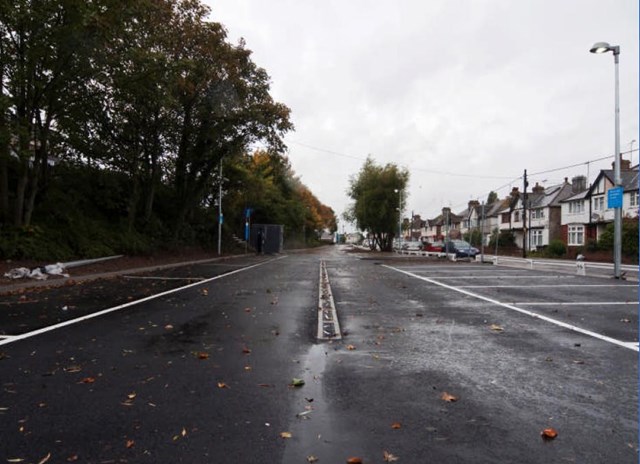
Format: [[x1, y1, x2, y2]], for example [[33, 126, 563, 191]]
[[589, 42, 622, 279]]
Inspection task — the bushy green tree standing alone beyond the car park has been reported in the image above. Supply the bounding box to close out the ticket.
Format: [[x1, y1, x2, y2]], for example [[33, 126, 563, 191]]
[[345, 157, 409, 251]]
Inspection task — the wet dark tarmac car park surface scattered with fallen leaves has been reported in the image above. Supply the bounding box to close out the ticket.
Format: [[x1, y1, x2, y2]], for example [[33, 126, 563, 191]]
[[0, 247, 638, 463]]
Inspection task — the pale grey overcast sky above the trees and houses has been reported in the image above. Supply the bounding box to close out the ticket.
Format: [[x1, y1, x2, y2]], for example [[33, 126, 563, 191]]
[[204, 0, 640, 231]]
